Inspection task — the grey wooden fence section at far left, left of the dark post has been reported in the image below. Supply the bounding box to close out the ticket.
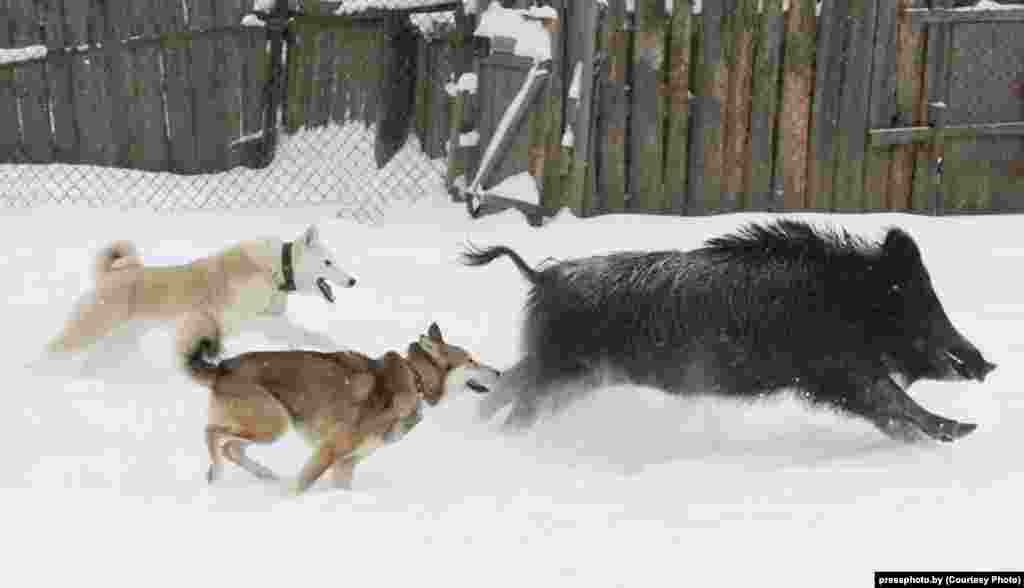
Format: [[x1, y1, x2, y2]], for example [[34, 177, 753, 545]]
[[0, 0, 267, 173]]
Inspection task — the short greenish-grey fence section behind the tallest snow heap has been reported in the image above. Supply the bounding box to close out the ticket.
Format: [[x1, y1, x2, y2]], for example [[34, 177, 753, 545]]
[[285, 3, 457, 165]]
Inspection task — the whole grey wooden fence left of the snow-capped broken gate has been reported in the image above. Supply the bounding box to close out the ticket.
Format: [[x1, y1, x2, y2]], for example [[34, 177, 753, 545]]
[[0, 0, 453, 174]]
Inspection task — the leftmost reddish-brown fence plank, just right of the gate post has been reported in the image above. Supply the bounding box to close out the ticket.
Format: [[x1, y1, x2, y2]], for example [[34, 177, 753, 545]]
[[596, 0, 626, 212]]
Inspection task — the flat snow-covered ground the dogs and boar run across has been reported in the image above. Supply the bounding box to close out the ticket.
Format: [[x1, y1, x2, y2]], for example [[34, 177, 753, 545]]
[[0, 194, 1024, 588]]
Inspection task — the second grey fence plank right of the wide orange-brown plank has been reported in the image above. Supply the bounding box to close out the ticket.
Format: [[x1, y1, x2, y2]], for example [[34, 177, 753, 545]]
[[833, 0, 888, 211]]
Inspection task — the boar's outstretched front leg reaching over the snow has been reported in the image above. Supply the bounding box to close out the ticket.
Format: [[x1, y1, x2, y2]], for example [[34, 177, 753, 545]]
[[845, 376, 978, 442]]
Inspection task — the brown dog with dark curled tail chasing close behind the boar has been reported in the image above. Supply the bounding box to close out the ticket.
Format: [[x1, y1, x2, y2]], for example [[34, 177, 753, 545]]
[[186, 324, 498, 493]]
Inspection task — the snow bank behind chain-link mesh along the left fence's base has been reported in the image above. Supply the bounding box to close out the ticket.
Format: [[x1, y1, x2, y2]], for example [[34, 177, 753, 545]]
[[0, 123, 445, 219]]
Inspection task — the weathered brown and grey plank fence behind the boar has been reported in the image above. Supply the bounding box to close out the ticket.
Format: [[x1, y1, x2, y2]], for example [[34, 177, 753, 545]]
[[462, 0, 1024, 215]]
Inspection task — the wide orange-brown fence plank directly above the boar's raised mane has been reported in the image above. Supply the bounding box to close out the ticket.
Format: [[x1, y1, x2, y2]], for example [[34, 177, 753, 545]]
[[775, 0, 817, 210]]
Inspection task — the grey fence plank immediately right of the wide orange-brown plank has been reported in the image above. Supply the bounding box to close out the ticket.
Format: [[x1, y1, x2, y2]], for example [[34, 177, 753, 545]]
[[807, 0, 850, 210]]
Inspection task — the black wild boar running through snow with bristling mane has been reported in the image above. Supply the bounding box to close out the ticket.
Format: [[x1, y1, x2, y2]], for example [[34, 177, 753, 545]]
[[464, 220, 995, 440]]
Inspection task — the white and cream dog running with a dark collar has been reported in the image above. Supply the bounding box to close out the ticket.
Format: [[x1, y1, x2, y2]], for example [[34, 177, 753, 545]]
[[47, 226, 355, 368]]
